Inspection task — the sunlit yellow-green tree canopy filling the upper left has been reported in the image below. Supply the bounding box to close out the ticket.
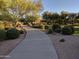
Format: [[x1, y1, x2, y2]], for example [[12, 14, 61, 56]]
[[0, 0, 42, 19]]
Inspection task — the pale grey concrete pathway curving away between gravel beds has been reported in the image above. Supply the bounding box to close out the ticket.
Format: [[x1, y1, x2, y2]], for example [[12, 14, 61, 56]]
[[5, 28, 58, 59]]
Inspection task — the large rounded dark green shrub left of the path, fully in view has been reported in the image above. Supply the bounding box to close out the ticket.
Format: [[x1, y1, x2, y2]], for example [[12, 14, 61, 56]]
[[6, 28, 20, 39]]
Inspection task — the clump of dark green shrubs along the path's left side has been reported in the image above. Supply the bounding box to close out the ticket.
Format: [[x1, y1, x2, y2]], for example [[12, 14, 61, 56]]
[[0, 28, 24, 40]]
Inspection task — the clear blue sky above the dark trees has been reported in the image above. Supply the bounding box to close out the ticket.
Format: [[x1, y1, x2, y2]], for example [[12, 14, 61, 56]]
[[42, 0, 79, 13]]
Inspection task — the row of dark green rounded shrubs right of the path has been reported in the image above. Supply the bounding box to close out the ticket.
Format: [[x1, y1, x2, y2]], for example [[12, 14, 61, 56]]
[[48, 24, 75, 35]]
